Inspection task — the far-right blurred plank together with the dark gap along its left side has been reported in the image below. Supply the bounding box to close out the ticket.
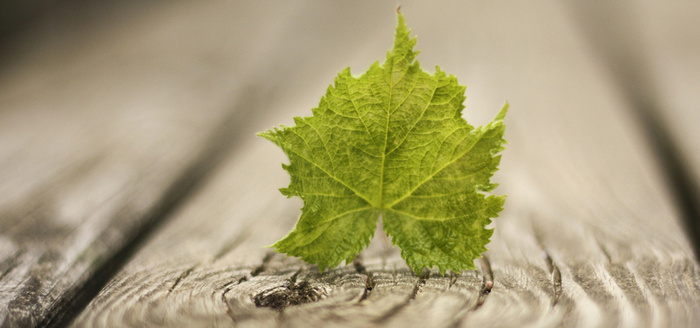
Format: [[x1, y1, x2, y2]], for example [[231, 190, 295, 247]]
[[570, 1, 700, 257]]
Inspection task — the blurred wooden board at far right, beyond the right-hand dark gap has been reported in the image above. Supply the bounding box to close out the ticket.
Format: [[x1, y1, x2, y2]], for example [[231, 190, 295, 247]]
[[638, 1, 700, 246]]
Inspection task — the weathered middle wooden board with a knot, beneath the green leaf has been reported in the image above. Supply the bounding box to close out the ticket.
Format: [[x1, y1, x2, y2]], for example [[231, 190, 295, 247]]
[[69, 1, 700, 327]]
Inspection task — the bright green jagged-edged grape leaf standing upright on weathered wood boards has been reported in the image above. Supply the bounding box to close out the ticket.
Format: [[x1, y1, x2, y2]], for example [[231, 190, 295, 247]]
[[259, 13, 508, 274]]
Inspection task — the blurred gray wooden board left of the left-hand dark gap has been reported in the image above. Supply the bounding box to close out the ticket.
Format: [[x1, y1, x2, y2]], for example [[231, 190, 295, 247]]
[[0, 3, 312, 327]]
